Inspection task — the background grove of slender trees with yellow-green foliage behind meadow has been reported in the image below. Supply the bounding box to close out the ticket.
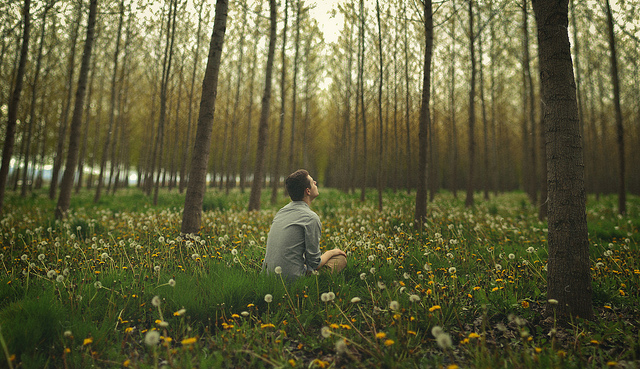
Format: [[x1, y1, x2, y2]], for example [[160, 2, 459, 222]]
[[0, 0, 640, 217]]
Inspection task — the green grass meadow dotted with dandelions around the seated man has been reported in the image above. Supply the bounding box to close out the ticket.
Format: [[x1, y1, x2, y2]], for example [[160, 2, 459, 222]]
[[0, 188, 640, 368]]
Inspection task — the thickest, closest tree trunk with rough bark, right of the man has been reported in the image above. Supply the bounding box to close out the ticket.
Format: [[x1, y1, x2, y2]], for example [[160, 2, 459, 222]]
[[533, 0, 593, 319]]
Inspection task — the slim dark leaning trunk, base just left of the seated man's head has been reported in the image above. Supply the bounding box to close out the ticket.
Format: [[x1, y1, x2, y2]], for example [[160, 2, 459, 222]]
[[249, 0, 277, 211]]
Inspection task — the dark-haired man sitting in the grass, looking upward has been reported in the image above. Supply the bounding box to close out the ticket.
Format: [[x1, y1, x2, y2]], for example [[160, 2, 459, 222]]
[[262, 169, 347, 278]]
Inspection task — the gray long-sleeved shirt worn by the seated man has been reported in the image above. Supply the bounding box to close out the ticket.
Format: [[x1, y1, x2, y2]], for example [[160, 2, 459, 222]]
[[262, 201, 322, 278]]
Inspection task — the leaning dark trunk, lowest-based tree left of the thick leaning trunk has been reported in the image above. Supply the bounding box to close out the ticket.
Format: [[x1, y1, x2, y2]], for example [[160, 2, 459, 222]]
[[55, 0, 98, 219]]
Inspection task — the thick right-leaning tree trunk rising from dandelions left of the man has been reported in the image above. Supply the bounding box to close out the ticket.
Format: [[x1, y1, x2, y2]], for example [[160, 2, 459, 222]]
[[181, 0, 229, 234]]
